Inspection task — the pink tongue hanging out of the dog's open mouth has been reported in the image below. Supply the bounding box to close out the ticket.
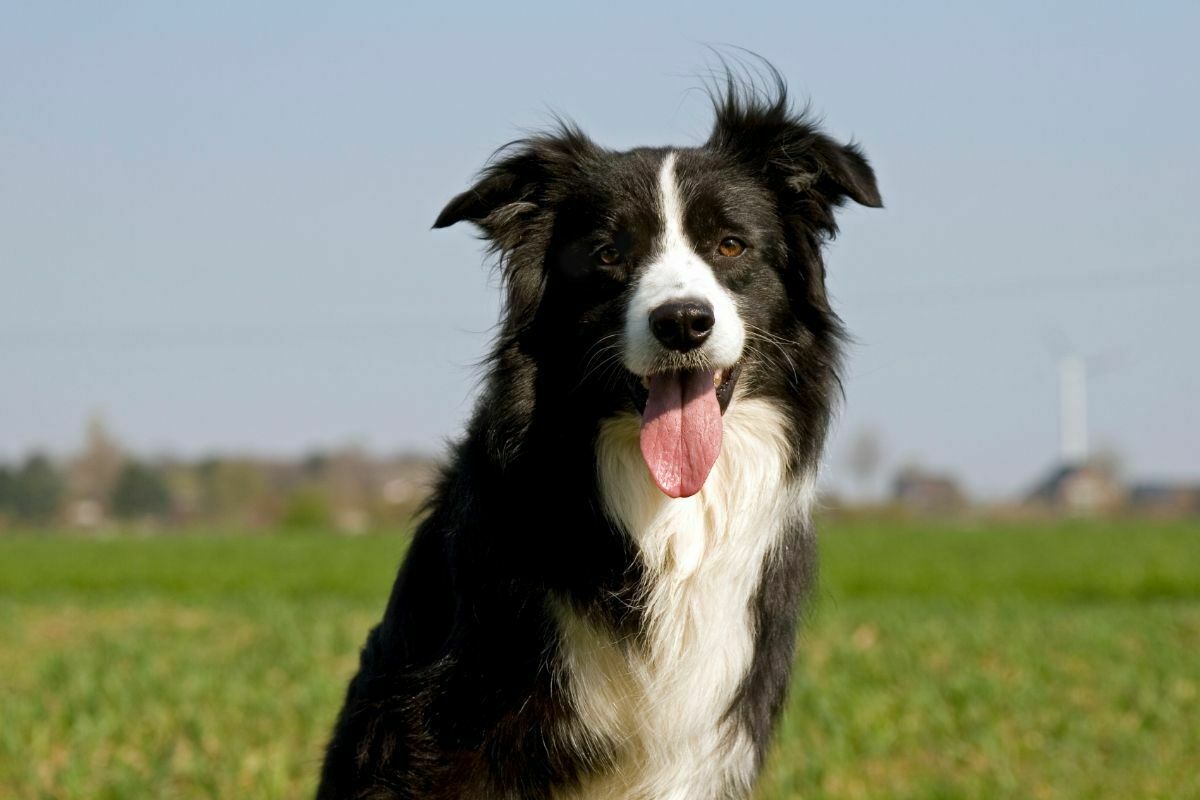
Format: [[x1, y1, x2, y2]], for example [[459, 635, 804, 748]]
[[642, 369, 721, 498]]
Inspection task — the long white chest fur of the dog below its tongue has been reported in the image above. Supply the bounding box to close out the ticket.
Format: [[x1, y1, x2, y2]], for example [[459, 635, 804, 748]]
[[559, 399, 814, 800]]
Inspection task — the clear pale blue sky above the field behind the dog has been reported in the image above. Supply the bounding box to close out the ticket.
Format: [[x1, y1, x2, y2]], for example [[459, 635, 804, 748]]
[[0, 0, 1200, 497]]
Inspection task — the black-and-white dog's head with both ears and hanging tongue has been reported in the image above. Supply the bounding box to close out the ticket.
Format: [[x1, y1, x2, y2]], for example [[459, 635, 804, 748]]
[[434, 86, 880, 497]]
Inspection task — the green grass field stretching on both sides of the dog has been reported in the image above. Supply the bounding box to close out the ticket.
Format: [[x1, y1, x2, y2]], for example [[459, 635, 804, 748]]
[[0, 522, 1200, 800]]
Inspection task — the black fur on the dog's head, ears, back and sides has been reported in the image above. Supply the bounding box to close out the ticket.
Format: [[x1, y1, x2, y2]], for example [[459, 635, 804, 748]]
[[318, 70, 880, 800]]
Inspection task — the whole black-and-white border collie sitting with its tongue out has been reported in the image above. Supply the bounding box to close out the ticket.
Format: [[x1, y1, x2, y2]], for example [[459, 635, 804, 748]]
[[318, 73, 881, 800]]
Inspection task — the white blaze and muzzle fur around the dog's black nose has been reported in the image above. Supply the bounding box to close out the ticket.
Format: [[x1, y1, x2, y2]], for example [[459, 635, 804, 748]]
[[625, 152, 745, 375]]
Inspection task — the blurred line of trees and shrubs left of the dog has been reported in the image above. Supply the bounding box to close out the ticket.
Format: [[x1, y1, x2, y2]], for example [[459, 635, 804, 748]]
[[0, 417, 436, 533]]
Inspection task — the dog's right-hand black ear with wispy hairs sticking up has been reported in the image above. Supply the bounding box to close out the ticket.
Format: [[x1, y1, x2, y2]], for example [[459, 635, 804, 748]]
[[708, 80, 883, 235]]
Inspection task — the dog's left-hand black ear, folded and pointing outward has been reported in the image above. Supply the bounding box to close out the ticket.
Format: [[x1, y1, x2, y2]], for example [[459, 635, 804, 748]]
[[433, 124, 595, 248]]
